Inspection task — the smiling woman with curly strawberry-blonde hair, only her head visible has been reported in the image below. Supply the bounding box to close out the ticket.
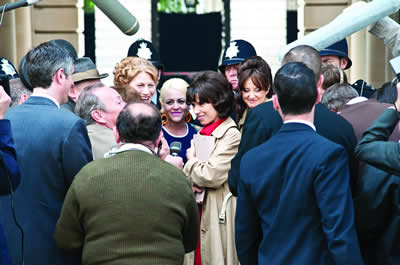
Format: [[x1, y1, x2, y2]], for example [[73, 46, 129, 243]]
[[113, 57, 158, 103]]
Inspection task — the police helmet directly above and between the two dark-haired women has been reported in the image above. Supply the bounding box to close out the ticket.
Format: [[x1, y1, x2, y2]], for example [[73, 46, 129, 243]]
[[218, 40, 257, 72]]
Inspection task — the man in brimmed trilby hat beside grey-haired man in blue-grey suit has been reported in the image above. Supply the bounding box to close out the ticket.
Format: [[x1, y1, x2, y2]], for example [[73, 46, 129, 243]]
[[61, 57, 108, 112]]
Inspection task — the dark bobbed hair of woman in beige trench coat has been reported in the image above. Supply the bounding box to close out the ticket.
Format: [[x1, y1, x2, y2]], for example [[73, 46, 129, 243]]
[[186, 71, 235, 119]]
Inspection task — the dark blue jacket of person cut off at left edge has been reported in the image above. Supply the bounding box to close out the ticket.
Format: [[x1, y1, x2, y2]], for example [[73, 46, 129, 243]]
[[0, 120, 20, 265]]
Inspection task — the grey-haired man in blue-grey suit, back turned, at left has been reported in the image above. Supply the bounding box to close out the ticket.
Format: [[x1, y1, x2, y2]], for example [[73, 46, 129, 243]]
[[0, 42, 92, 265]]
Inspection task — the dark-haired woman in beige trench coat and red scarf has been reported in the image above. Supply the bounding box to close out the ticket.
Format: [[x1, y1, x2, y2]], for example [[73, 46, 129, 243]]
[[183, 71, 240, 265]]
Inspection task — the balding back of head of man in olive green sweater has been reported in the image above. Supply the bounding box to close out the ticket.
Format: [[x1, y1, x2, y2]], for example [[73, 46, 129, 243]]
[[117, 102, 161, 143]]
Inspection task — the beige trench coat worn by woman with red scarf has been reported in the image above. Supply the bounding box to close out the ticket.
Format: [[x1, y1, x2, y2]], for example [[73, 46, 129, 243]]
[[183, 118, 240, 265]]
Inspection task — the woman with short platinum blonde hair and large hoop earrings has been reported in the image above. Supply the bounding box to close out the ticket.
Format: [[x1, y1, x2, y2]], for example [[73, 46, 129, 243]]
[[160, 78, 197, 163]]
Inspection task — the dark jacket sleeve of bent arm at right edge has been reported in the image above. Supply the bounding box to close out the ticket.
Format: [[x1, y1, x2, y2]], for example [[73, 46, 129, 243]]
[[356, 109, 400, 175]]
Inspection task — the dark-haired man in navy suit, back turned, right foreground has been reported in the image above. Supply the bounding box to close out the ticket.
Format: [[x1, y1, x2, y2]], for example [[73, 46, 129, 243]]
[[235, 62, 363, 265]]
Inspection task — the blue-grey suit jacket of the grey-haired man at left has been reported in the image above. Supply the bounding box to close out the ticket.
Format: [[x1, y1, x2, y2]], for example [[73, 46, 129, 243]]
[[0, 96, 92, 265]]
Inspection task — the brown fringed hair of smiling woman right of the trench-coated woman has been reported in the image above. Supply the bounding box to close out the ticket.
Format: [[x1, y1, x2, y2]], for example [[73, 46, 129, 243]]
[[236, 56, 273, 121]]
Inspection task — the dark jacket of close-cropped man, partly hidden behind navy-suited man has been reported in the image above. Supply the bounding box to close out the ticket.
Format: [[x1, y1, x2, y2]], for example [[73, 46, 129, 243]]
[[228, 101, 358, 196]]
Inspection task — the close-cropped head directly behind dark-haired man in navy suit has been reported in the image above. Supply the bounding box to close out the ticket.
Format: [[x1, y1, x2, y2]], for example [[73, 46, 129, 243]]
[[282, 45, 321, 83]]
